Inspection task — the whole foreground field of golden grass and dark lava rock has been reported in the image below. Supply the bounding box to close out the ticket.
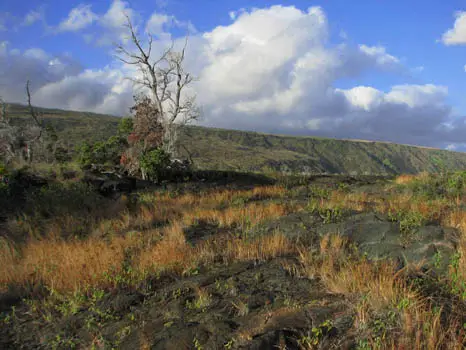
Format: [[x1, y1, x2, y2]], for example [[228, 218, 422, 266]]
[[0, 173, 466, 350]]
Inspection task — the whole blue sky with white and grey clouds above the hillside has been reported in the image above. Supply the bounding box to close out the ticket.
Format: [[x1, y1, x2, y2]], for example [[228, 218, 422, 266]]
[[0, 0, 466, 151]]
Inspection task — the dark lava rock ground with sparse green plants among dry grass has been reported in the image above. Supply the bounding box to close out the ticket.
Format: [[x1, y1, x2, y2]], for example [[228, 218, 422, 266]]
[[0, 176, 462, 349]]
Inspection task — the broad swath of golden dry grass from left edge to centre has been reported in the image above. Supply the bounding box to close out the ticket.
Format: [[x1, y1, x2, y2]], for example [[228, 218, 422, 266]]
[[0, 186, 294, 291]]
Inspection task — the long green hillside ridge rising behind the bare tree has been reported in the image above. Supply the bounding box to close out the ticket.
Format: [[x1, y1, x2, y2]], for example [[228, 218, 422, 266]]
[[6, 105, 466, 174]]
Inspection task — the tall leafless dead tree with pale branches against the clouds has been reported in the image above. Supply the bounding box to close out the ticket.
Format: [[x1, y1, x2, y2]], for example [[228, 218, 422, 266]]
[[115, 16, 200, 156]]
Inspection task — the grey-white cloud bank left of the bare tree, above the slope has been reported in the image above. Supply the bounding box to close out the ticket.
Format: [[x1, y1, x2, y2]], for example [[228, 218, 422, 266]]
[[0, 42, 132, 115]]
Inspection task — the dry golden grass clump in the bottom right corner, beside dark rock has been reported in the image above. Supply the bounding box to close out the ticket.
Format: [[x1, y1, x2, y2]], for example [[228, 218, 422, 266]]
[[300, 235, 466, 350]]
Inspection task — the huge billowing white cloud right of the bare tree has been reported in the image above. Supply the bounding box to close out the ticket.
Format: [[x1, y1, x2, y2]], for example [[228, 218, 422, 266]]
[[188, 6, 464, 147]]
